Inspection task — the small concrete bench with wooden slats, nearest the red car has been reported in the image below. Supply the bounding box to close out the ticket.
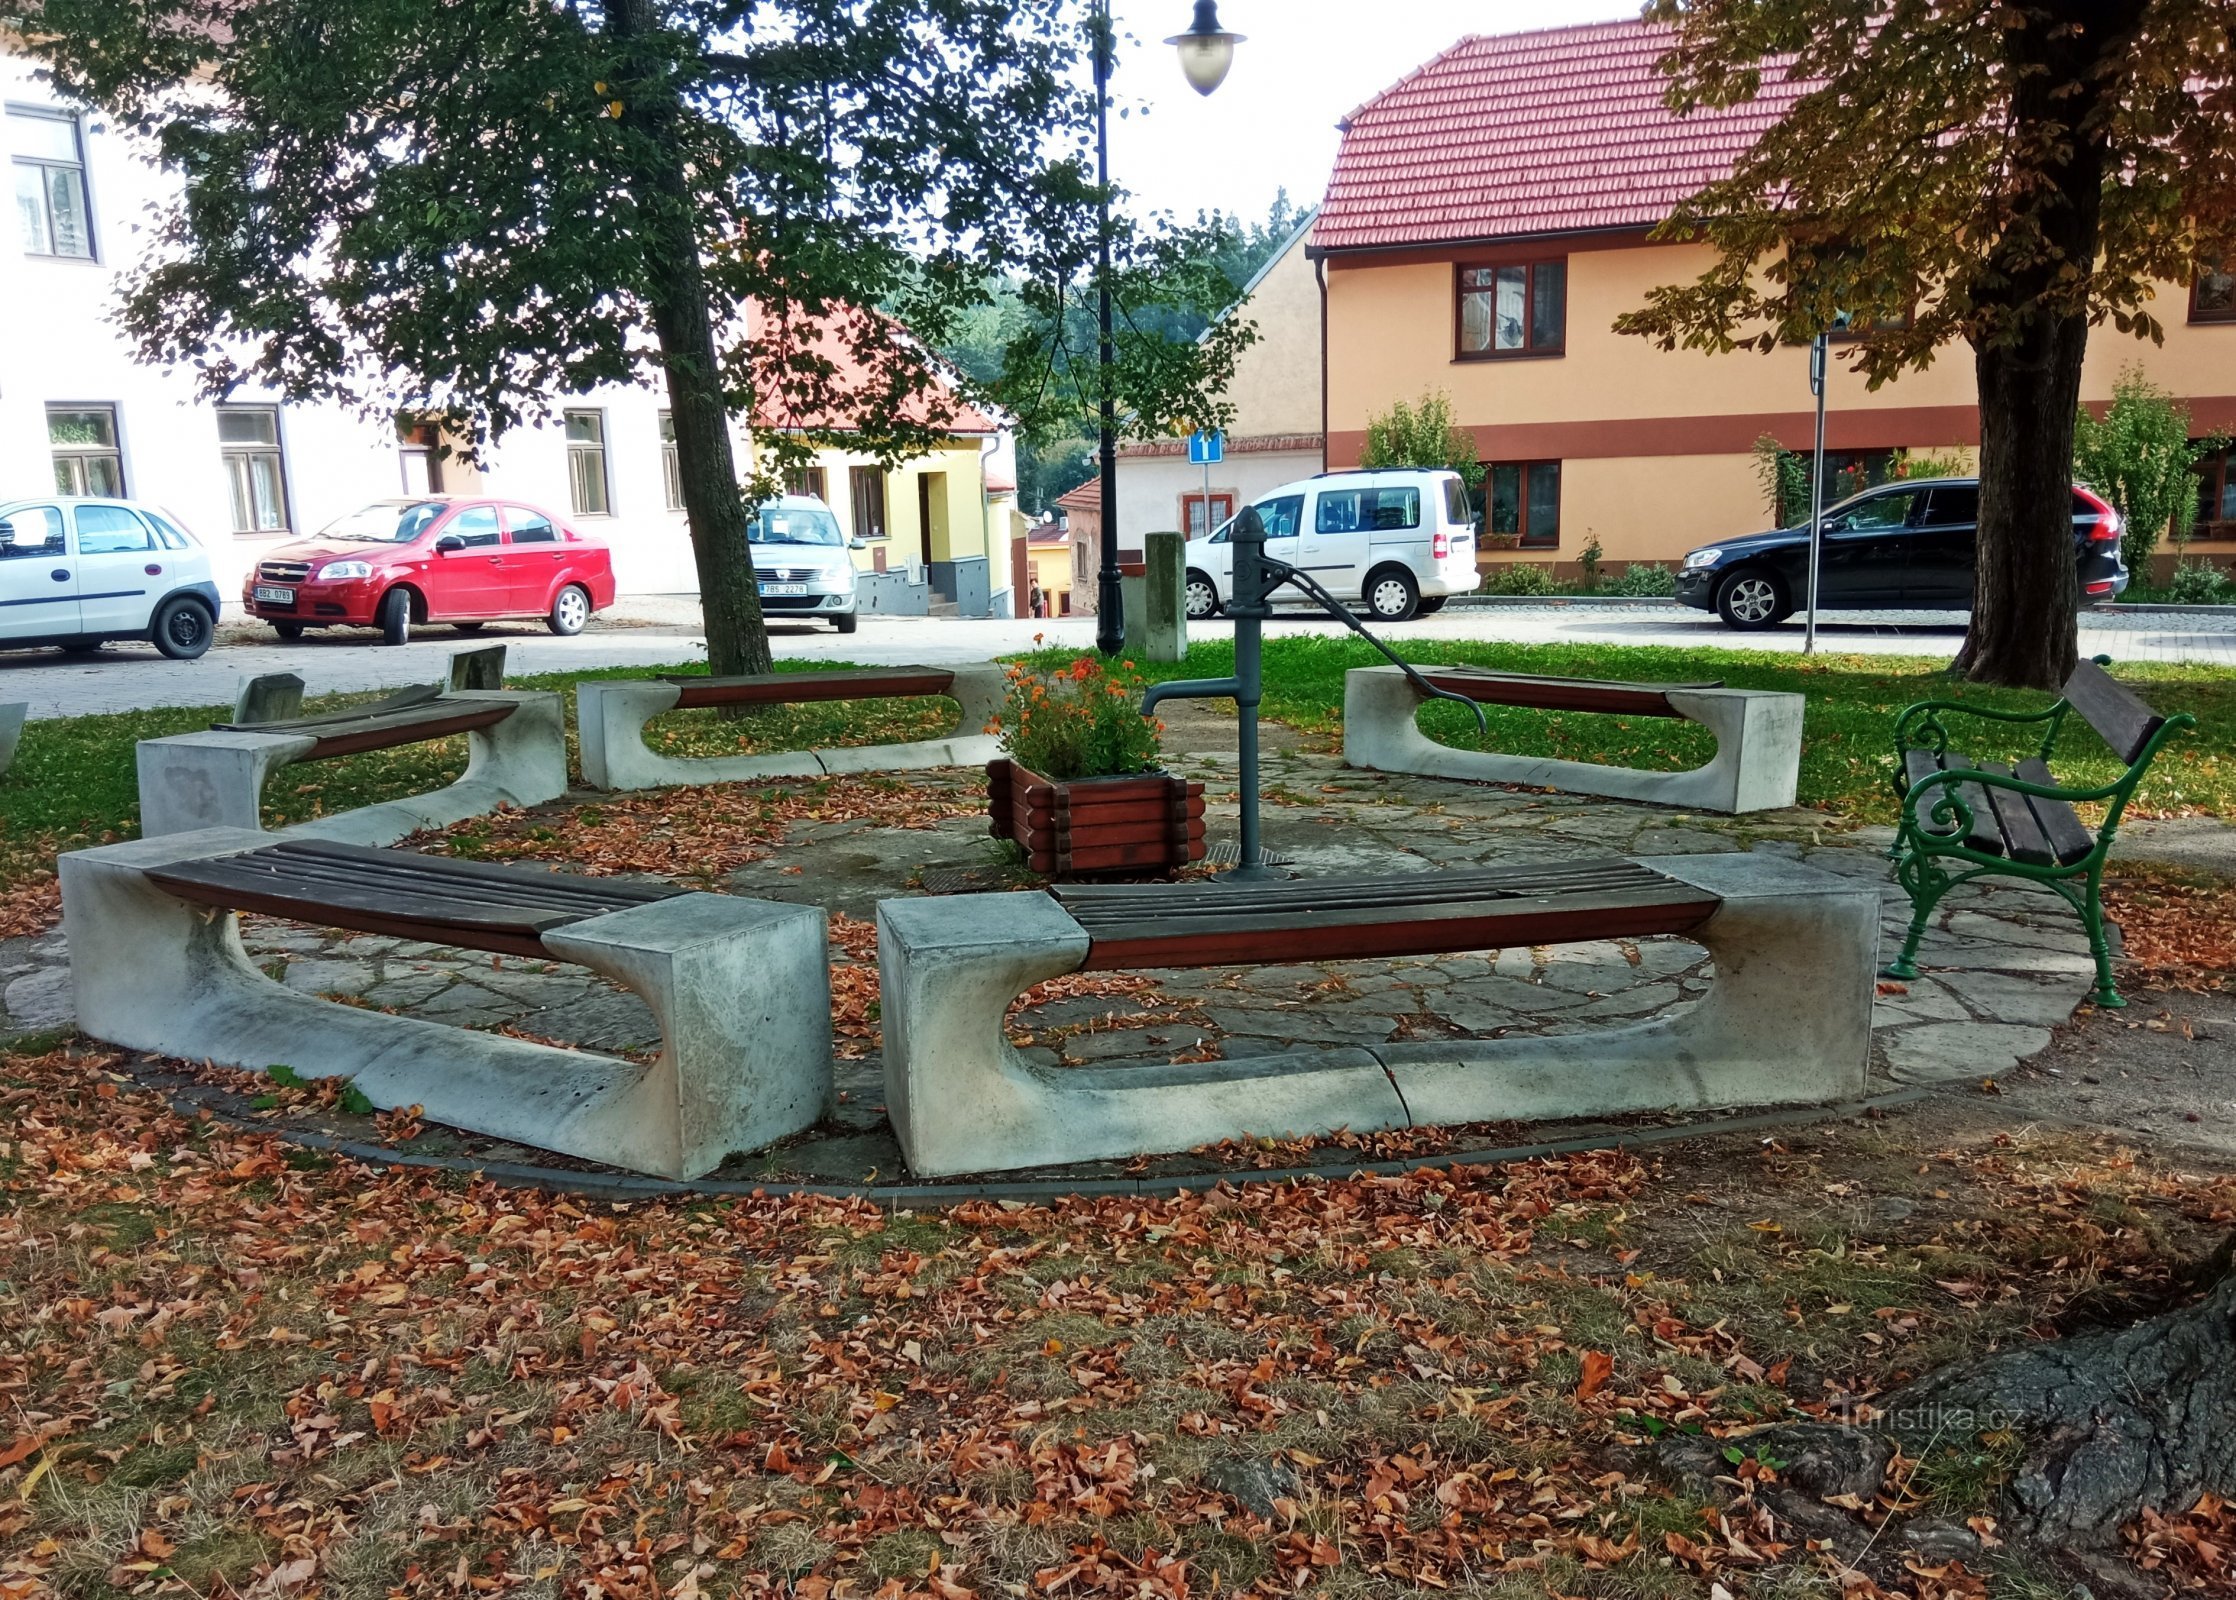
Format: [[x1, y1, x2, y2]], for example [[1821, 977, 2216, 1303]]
[[139, 686, 568, 845]]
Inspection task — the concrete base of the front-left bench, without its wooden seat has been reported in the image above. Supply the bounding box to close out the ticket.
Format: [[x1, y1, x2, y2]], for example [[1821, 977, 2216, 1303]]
[[60, 829, 830, 1178]]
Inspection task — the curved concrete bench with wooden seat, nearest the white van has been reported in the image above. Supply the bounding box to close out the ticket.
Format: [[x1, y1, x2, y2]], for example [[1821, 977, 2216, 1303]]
[[1344, 666, 1804, 811]]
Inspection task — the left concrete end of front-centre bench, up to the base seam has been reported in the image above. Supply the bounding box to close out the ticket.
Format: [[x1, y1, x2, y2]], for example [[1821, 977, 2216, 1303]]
[[877, 894, 1406, 1178]]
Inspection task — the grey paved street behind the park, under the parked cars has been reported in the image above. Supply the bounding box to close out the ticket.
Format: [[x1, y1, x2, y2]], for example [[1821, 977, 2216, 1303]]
[[0, 599, 2236, 717]]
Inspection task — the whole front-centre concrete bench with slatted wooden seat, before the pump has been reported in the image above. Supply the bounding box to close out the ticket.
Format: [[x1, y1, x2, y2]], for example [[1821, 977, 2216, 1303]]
[[877, 854, 1878, 1178]]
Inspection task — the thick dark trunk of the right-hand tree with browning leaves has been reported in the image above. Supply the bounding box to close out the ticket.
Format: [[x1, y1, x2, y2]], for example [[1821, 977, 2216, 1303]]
[[1957, 0, 2144, 688]]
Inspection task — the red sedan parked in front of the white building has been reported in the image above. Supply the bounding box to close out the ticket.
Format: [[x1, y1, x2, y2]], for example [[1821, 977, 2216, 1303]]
[[241, 498, 613, 644]]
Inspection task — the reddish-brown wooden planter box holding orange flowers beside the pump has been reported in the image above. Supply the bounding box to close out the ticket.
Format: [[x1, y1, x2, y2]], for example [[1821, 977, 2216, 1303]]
[[986, 758, 1203, 878]]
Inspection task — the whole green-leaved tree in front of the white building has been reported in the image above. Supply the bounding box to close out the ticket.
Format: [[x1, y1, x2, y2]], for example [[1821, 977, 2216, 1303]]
[[0, 0, 1243, 673]]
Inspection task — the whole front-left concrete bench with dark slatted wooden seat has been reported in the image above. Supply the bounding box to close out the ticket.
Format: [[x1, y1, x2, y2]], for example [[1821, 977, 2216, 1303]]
[[60, 829, 832, 1178]]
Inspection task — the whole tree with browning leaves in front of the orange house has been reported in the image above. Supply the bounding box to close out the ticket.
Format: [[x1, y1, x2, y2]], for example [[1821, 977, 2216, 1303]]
[[1617, 0, 2236, 688]]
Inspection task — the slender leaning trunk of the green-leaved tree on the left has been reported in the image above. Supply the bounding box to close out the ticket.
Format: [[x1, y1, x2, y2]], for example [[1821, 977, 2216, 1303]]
[[606, 0, 769, 677]]
